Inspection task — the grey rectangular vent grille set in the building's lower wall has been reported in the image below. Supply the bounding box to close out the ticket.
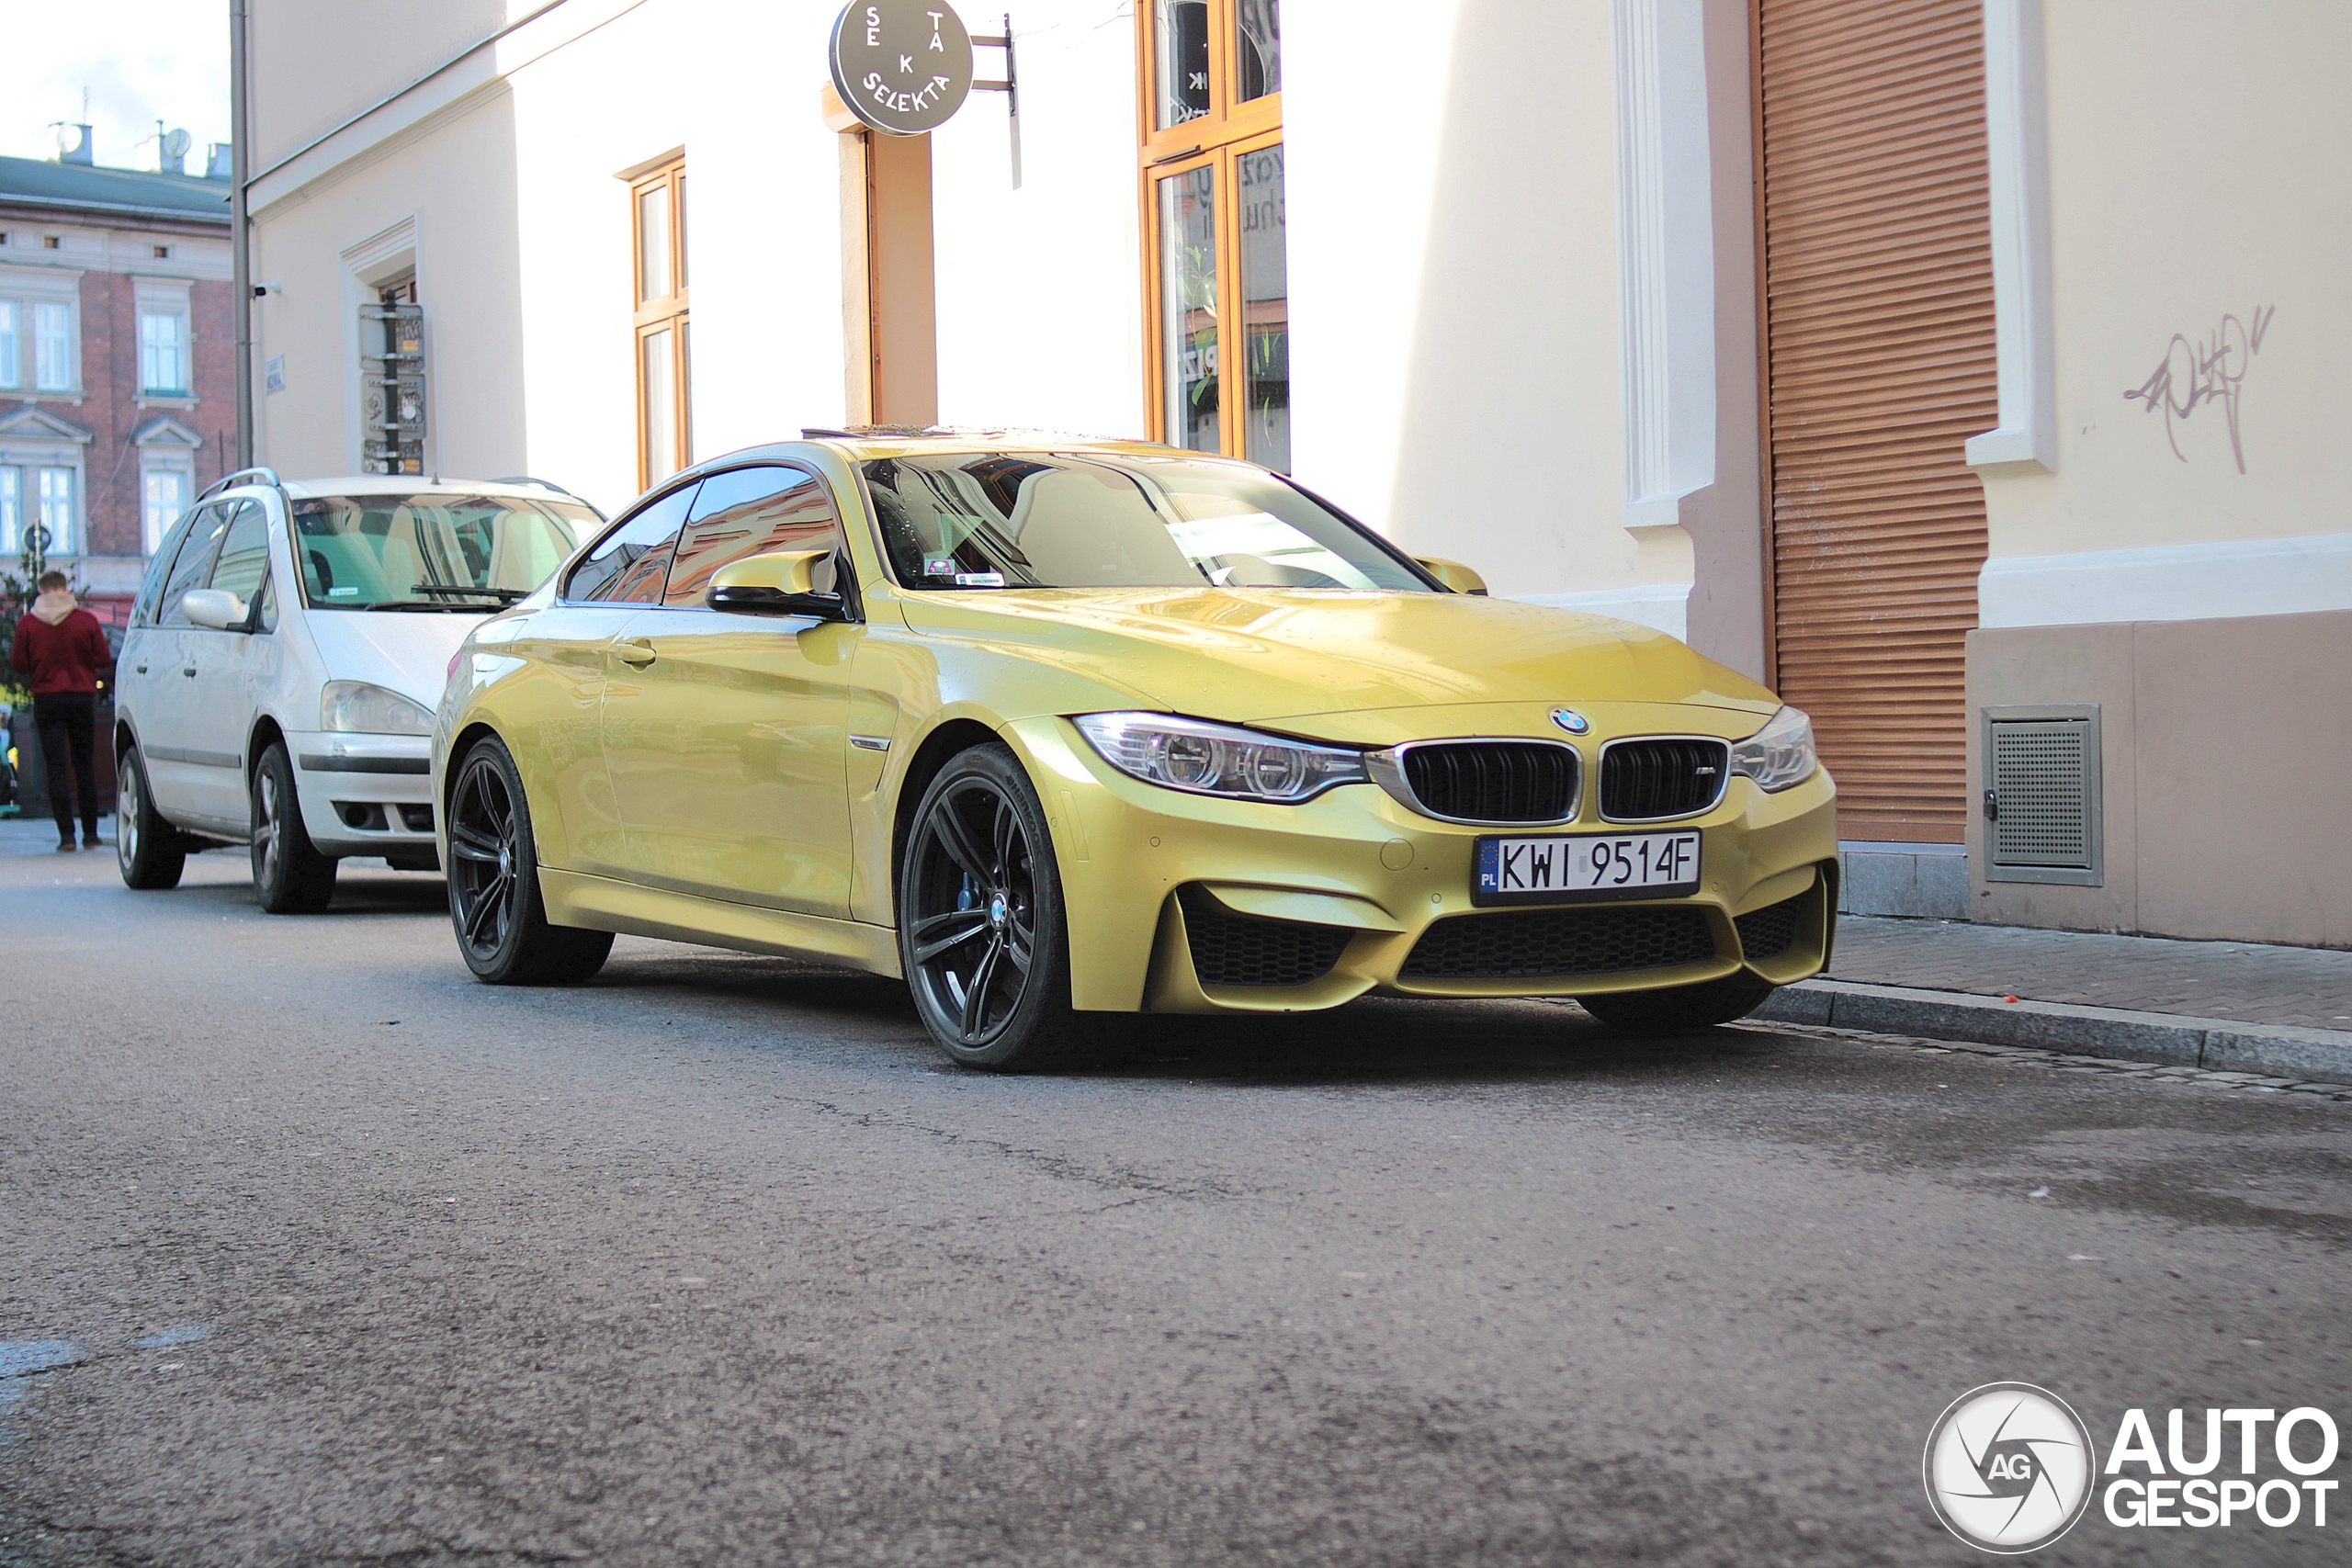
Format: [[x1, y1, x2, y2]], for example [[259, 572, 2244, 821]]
[[1985, 705, 2105, 886]]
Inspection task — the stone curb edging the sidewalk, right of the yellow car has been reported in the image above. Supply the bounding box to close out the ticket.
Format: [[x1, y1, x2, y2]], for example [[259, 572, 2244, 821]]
[[1750, 980, 2352, 1084]]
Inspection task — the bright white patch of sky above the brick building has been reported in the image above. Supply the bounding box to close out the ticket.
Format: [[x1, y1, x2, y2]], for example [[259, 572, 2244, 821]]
[[0, 0, 228, 174]]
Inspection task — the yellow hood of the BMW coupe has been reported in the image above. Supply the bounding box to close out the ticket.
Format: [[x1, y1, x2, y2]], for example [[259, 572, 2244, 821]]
[[903, 588, 1776, 728]]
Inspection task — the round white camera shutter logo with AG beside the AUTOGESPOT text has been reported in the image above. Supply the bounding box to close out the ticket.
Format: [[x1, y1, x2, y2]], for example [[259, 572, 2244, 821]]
[[1922, 1382, 2098, 1556]]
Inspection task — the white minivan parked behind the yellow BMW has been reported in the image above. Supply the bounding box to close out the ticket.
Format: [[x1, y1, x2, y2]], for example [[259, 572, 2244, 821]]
[[115, 468, 602, 915]]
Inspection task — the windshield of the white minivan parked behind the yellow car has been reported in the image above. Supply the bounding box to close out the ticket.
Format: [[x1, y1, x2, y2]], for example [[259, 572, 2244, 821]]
[[294, 493, 597, 614]]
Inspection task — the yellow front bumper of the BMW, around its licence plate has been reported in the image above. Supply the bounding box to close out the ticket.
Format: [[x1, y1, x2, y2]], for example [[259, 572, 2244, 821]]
[[1007, 719, 1837, 1013]]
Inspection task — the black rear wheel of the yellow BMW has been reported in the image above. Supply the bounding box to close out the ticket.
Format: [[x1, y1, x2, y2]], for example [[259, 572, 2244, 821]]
[[449, 736, 612, 985]]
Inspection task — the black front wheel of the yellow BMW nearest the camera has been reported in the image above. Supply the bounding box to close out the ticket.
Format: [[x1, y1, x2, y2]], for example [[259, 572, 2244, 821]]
[[899, 745, 1114, 1072]]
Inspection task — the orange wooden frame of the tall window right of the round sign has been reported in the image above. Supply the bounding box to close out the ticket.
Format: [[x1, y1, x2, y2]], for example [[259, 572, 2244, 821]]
[[1136, 0, 1282, 458]]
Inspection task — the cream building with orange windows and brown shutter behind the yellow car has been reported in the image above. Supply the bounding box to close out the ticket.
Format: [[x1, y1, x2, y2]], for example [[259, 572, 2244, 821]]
[[238, 0, 2352, 945]]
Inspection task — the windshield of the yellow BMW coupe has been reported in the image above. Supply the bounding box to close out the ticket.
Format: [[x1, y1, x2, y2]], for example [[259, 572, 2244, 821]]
[[864, 451, 1430, 592]]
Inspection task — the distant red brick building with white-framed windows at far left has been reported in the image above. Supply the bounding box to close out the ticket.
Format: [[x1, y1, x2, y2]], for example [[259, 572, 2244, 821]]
[[0, 127, 235, 626]]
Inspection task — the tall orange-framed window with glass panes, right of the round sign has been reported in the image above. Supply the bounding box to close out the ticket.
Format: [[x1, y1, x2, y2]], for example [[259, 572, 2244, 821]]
[[1136, 0, 1291, 470]]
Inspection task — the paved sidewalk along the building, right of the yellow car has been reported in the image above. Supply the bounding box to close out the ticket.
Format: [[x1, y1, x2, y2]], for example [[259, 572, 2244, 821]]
[[1830, 915, 2352, 1032]]
